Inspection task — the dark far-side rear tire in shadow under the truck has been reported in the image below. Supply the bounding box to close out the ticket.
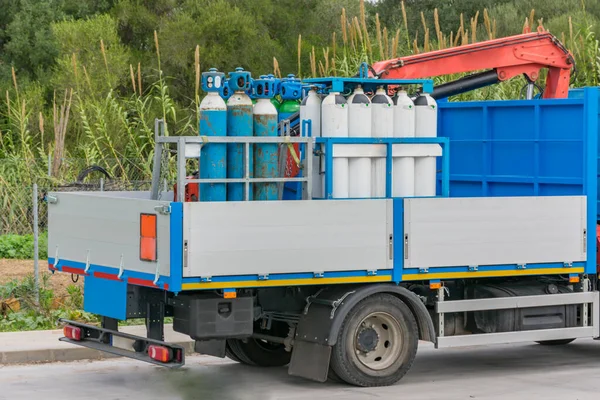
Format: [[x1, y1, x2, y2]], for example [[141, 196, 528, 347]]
[[225, 338, 292, 367]]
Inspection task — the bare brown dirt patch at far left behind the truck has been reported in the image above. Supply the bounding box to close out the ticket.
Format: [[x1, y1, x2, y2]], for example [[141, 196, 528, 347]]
[[0, 259, 83, 297]]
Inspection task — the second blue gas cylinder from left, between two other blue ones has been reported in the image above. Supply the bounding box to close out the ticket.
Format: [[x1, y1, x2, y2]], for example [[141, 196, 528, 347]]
[[227, 68, 253, 201]]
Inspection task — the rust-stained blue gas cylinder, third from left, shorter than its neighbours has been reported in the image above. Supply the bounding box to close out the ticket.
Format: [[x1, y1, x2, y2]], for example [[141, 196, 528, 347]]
[[252, 77, 279, 200]]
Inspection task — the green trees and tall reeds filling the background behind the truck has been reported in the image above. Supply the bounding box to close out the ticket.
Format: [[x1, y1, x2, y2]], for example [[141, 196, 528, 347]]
[[0, 0, 600, 233]]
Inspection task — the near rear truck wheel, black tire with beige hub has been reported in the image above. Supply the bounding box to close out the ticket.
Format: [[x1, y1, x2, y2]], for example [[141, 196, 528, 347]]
[[331, 294, 419, 387]]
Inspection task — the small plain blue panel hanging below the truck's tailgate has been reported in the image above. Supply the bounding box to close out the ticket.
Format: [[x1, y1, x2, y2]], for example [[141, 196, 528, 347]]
[[83, 275, 127, 320]]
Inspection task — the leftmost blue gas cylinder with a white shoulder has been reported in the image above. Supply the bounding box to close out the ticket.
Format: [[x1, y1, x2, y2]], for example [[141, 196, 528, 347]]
[[199, 68, 227, 201]]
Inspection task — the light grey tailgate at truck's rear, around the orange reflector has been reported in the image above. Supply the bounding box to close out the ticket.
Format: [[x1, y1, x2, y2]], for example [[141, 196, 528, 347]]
[[48, 192, 170, 276]]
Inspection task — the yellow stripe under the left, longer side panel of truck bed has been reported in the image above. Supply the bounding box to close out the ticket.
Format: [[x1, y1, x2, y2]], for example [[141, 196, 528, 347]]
[[181, 275, 392, 290]]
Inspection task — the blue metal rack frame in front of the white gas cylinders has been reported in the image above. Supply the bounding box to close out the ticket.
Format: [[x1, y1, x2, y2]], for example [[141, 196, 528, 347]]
[[315, 137, 450, 199]]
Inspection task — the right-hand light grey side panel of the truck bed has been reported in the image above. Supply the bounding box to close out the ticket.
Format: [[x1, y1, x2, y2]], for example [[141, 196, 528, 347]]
[[404, 196, 586, 268]]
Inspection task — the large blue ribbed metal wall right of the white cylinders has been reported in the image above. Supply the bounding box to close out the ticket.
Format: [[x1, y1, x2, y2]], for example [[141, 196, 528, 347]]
[[438, 88, 600, 273]]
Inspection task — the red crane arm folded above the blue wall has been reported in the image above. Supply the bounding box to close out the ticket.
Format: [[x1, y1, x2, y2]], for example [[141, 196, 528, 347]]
[[372, 31, 574, 98]]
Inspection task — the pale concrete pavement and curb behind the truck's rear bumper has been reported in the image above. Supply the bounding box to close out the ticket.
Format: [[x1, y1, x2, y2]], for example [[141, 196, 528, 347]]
[[0, 325, 193, 365]]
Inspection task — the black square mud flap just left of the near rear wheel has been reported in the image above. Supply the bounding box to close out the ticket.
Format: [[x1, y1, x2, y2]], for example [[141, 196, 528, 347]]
[[288, 340, 331, 382]]
